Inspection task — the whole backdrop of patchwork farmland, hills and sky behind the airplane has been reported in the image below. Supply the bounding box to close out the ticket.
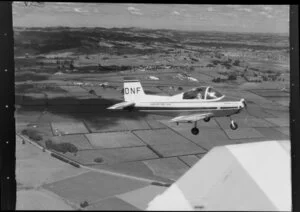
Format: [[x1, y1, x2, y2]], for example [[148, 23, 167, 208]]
[[13, 2, 290, 210]]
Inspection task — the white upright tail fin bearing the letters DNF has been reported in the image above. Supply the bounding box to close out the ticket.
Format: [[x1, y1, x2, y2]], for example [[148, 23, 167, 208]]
[[124, 79, 146, 102]]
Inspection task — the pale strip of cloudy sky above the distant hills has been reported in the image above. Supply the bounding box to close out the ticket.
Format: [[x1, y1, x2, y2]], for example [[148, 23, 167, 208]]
[[13, 2, 289, 33]]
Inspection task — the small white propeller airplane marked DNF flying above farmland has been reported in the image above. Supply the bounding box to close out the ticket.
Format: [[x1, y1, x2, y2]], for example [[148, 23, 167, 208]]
[[107, 78, 247, 135]]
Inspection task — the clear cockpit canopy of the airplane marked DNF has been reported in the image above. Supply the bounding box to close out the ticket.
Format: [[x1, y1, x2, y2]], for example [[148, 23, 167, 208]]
[[182, 87, 223, 100]]
